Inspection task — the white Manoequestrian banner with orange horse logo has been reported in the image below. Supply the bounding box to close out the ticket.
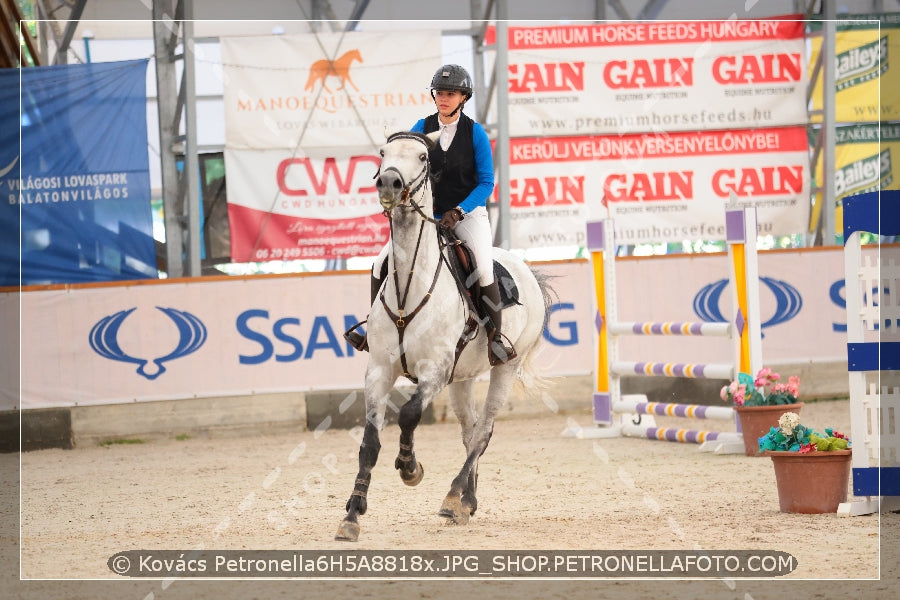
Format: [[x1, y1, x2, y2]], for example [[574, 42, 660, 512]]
[[221, 30, 441, 152]]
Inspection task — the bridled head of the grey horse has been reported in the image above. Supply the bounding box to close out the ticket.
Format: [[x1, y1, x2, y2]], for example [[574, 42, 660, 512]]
[[375, 131, 440, 213]]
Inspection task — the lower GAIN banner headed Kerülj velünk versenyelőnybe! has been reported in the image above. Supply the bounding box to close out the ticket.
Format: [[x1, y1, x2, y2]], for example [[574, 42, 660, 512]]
[[510, 127, 809, 248]]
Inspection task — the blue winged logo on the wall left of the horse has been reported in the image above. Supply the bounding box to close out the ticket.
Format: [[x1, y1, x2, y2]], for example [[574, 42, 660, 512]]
[[89, 306, 206, 381]]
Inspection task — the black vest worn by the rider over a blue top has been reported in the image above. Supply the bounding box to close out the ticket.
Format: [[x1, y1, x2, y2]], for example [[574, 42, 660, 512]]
[[424, 113, 478, 214]]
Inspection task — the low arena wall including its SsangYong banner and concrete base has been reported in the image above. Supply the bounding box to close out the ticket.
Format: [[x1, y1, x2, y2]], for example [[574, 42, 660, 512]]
[[0, 248, 848, 447]]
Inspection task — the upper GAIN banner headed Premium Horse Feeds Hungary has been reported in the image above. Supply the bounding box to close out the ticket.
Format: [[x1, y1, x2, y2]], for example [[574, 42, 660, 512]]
[[500, 16, 807, 136]]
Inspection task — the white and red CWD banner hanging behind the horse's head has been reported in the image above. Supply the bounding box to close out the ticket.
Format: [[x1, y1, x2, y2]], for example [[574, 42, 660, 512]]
[[225, 148, 390, 262]]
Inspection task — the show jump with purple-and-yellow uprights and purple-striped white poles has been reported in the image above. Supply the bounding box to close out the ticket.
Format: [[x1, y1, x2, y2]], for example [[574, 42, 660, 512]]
[[570, 196, 762, 454]]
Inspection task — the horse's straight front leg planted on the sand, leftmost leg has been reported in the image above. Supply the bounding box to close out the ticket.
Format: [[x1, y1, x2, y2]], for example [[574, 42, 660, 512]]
[[334, 372, 391, 542]]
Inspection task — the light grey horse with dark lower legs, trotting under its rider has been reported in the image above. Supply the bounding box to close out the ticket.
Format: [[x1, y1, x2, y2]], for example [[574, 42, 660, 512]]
[[335, 132, 551, 541]]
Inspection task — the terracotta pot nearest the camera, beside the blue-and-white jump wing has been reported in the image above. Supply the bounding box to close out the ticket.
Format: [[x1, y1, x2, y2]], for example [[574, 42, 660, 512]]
[[763, 450, 853, 513]]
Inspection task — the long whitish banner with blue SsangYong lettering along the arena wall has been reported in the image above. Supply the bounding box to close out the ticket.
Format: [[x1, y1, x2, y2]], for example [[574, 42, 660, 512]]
[[0, 248, 847, 410]]
